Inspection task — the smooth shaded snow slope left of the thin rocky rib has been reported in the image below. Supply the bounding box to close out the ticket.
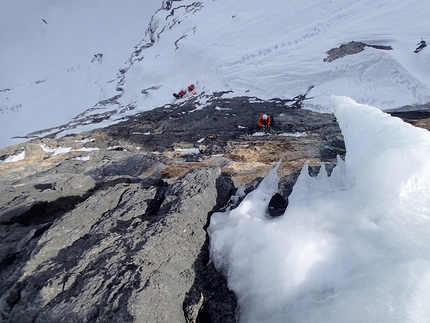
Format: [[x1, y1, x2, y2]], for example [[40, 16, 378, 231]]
[[0, 0, 161, 147]]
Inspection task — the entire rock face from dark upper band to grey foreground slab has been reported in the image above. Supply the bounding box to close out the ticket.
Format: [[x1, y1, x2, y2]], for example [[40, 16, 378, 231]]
[[0, 94, 428, 322]]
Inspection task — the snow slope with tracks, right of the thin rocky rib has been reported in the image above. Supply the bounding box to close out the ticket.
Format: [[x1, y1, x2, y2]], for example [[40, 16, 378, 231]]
[[122, 0, 430, 110]]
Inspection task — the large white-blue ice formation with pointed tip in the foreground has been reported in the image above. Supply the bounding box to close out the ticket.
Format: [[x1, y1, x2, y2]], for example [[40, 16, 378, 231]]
[[208, 97, 430, 323]]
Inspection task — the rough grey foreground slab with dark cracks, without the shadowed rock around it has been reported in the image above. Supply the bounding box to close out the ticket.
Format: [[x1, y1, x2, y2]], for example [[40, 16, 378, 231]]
[[0, 168, 234, 323]]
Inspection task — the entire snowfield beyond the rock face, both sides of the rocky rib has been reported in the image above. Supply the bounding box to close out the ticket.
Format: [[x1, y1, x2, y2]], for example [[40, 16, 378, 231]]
[[0, 0, 430, 147]]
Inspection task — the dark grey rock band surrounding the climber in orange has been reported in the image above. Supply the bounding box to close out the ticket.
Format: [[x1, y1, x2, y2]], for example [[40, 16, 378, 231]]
[[106, 93, 340, 155]]
